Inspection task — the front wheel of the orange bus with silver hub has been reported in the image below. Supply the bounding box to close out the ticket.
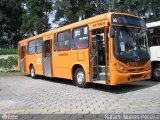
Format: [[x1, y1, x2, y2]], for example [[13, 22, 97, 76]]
[[74, 67, 87, 88]]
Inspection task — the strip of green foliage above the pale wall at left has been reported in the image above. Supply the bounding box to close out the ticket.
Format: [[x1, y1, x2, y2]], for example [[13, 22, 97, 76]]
[[0, 48, 18, 55]]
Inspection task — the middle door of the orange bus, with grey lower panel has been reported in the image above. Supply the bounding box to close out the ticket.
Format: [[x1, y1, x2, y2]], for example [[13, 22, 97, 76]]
[[43, 40, 51, 76]]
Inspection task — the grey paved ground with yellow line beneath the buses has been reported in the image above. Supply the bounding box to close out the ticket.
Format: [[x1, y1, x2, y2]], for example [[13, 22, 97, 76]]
[[0, 76, 160, 119]]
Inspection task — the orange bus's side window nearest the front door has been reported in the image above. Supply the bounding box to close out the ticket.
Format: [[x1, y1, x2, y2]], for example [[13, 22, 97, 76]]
[[72, 26, 89, 49]]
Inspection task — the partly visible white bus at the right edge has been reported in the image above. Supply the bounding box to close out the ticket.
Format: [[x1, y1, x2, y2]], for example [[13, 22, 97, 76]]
[[147, 21, 160, 81]]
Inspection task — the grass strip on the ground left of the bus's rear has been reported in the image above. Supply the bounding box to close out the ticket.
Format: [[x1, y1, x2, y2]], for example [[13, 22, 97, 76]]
[[0, 71, 25, 77]]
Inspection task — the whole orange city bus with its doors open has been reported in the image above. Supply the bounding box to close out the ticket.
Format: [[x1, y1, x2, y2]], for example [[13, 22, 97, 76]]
[[18, 12, 151, 87]]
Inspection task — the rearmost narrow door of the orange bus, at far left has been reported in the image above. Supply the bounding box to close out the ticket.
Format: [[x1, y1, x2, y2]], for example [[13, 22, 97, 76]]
[[20, 46, 26, 72]]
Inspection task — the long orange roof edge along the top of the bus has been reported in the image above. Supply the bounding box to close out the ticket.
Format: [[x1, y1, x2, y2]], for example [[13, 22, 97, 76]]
[[19, 12, 139, 43]]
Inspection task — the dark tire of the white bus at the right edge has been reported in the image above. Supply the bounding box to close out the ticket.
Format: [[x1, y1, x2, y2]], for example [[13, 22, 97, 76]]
[[152, 64, 160, 81]]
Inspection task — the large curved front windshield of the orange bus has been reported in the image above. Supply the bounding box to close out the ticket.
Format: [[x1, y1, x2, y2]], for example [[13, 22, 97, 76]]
[[114, 26, 150, 62]]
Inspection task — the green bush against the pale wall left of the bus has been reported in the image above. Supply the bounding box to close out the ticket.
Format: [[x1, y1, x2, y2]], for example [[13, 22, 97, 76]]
[[0, 56, 18, 70]]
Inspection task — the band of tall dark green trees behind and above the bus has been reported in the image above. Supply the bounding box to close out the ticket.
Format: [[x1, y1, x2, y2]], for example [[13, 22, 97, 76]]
[[0, 0, 160, 48]]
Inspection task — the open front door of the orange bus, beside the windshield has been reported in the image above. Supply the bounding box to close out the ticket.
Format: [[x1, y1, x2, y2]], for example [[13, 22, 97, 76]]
[[90, 28, 106, 84]]
